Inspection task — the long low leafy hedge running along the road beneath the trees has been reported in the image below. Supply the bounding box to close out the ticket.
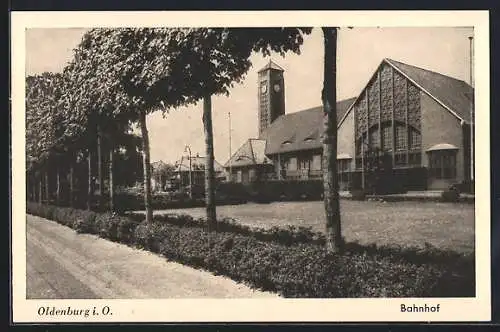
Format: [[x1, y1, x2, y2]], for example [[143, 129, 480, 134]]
[[27, 203, 475, 298]]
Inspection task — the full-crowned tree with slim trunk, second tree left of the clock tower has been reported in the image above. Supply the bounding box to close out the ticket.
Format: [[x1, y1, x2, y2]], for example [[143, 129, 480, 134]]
[[70, 28, 199, 222]]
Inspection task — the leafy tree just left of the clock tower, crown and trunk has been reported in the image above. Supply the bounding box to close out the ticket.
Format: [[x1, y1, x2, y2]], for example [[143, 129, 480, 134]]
[[165, 28, 311, 230]]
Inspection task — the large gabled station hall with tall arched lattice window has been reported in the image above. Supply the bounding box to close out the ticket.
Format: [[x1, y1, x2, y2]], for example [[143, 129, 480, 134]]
[[338, 59, 474, 190]]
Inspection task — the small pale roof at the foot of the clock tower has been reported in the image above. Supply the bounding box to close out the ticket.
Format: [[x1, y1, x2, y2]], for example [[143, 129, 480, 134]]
[[224, 138, 271, 167]]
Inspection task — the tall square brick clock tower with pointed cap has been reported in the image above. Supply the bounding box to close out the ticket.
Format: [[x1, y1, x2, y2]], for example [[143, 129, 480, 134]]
[[258, 60, 285, 136]]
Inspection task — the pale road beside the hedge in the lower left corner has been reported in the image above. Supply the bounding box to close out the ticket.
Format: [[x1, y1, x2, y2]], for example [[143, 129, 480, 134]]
[[26, 215, 276, 299]]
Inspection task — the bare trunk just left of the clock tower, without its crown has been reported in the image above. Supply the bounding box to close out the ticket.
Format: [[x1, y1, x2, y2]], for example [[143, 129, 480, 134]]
[[203, 94, 217, 231]]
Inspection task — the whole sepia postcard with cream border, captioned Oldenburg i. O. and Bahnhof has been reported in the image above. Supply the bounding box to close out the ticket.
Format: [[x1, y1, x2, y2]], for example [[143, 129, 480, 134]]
[[11, 11, 491, 323]]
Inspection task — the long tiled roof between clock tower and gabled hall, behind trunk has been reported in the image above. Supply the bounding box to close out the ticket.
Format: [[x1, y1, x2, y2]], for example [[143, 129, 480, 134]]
[[259, 98, 356, 155]]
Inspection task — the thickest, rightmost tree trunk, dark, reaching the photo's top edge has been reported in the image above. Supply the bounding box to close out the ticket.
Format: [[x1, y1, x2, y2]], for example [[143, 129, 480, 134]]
[[322, 28, 342, 253]]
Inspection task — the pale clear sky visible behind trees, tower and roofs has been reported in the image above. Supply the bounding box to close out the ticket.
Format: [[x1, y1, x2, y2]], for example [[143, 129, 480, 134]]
[[26, 27, 473, 164]]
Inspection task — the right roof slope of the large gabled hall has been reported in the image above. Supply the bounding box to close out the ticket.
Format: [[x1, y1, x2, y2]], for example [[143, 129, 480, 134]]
[[384, 59, 474, 123]]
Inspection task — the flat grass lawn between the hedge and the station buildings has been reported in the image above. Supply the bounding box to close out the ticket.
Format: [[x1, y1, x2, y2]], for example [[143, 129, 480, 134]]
[[147, 200, 474, 253]]
